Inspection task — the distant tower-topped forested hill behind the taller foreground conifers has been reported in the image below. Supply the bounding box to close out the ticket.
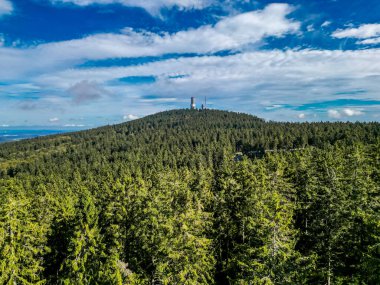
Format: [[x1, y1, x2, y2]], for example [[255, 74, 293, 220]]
[[0, 110, 380, 173]]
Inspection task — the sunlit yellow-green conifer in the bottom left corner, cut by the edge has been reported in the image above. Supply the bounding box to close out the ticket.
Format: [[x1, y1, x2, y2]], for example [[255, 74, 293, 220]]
[[0, 181, 48, 284]]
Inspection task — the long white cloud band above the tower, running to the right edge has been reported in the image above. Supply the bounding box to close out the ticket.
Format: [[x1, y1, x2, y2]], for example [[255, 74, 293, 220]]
[[37, 49, 380, 91]]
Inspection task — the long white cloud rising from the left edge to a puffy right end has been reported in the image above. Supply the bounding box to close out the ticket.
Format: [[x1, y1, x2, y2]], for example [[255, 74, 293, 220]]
[[0, 4, 300, 79]]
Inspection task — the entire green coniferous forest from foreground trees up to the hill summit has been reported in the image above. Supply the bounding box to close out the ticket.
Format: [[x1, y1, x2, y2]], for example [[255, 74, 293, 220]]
[[0, 110, 380, 285]]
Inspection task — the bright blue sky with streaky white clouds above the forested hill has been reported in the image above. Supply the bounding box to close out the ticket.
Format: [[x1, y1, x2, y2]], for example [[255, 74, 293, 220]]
[[0, 0, 380, 128]]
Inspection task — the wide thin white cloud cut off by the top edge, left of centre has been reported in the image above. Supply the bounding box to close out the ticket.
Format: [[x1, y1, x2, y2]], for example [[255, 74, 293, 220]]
[[50, 0, 213, 15]]
